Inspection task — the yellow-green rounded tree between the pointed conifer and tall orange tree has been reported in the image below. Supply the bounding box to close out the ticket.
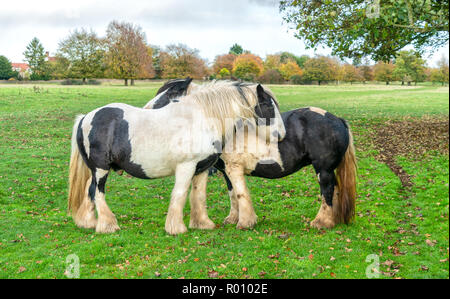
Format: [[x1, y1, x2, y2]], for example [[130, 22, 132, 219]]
[[54, 29, 105, 83]]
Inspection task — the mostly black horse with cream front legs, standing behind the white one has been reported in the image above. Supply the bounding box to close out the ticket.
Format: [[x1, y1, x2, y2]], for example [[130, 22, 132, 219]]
[[145, 78, 357, 228]]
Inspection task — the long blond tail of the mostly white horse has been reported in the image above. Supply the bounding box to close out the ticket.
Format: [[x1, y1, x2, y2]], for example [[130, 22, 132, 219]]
[[68, 115, 91, 217]]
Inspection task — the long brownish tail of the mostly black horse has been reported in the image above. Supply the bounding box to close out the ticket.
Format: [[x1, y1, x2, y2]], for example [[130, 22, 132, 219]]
[[335, 121, 357, 224]]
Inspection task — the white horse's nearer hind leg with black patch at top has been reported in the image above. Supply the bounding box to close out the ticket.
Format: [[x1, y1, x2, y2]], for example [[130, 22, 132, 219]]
[[89, 168, 120, 233]]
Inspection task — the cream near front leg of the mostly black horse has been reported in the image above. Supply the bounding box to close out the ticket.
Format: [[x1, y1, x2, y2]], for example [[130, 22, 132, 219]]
[[225, 163, 258, 229]]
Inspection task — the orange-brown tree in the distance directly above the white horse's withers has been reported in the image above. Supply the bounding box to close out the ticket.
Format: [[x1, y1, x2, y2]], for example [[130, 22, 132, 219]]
[[160, 44, 208, 79]]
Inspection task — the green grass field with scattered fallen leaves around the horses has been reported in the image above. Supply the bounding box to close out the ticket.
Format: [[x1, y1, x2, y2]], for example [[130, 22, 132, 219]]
[[0, 83, 449, 279]]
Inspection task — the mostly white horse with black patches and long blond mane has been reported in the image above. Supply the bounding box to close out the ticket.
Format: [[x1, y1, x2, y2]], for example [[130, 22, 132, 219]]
[[68, 82, 285, 234]]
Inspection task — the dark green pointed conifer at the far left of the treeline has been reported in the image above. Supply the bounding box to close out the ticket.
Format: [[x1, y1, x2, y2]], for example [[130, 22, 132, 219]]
[[23, 37, 50, 80]]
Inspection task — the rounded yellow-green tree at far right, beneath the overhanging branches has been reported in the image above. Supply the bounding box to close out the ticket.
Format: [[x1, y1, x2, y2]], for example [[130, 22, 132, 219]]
[[394, 50, 425, 85]]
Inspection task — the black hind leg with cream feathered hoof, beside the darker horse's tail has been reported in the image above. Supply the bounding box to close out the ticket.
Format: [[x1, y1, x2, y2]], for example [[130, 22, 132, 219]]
[[311, 171, 336, 229]]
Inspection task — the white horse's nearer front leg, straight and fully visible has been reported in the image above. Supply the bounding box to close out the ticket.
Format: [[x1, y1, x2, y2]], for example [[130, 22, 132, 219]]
[[165, 163, 196, 235]]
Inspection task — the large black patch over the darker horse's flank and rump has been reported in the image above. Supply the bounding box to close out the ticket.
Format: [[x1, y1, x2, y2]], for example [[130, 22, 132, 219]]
[[251, 108, 349, 206]]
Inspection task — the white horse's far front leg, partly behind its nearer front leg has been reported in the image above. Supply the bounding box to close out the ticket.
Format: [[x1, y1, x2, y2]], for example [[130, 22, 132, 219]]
[[189, 171, 216, 229]]
